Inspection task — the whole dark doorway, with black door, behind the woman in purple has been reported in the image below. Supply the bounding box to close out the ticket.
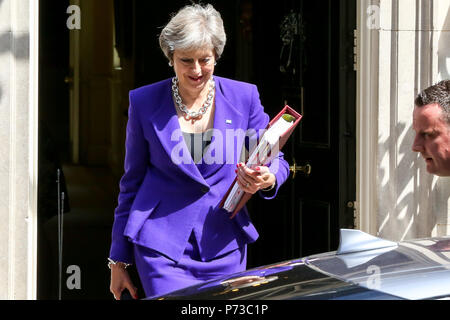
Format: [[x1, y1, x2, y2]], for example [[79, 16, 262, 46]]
[[38, 0, 356, 299]]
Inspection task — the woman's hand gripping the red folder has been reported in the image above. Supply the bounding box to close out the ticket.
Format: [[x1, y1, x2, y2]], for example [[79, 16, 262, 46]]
[[236, 163, 277, 194]]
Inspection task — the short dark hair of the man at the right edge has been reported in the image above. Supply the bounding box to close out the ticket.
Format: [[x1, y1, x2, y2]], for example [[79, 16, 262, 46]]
[[414, 80, 450, 123]]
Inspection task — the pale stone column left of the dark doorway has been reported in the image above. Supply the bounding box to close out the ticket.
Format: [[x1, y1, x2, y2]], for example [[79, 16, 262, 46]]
[[0, 0, 38, 299]]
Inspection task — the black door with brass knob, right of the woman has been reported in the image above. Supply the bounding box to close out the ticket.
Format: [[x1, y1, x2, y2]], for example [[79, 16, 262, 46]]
[[241, 0, 356, 266]]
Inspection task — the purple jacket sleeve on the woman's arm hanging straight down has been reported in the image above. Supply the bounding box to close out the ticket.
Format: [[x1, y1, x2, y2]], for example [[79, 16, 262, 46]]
[[109, 92, 149, 263]]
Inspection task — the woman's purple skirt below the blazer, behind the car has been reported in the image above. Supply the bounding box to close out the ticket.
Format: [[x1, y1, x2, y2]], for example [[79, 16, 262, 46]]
[[134, 233, 247, 297]]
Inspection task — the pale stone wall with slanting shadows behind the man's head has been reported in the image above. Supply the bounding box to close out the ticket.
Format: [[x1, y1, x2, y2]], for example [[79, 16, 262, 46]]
[[358, 0, 450, 240]]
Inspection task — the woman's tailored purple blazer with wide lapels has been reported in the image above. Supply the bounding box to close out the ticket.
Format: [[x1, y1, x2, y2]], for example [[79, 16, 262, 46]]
[[110, 76, 289, 263]]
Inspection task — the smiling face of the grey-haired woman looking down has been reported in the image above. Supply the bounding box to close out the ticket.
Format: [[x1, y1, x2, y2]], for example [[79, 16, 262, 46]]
[[173, 49, 216, 94]]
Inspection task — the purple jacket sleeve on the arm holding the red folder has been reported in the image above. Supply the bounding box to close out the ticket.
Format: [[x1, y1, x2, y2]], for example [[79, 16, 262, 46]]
[[248, 86, 289, 199]]
